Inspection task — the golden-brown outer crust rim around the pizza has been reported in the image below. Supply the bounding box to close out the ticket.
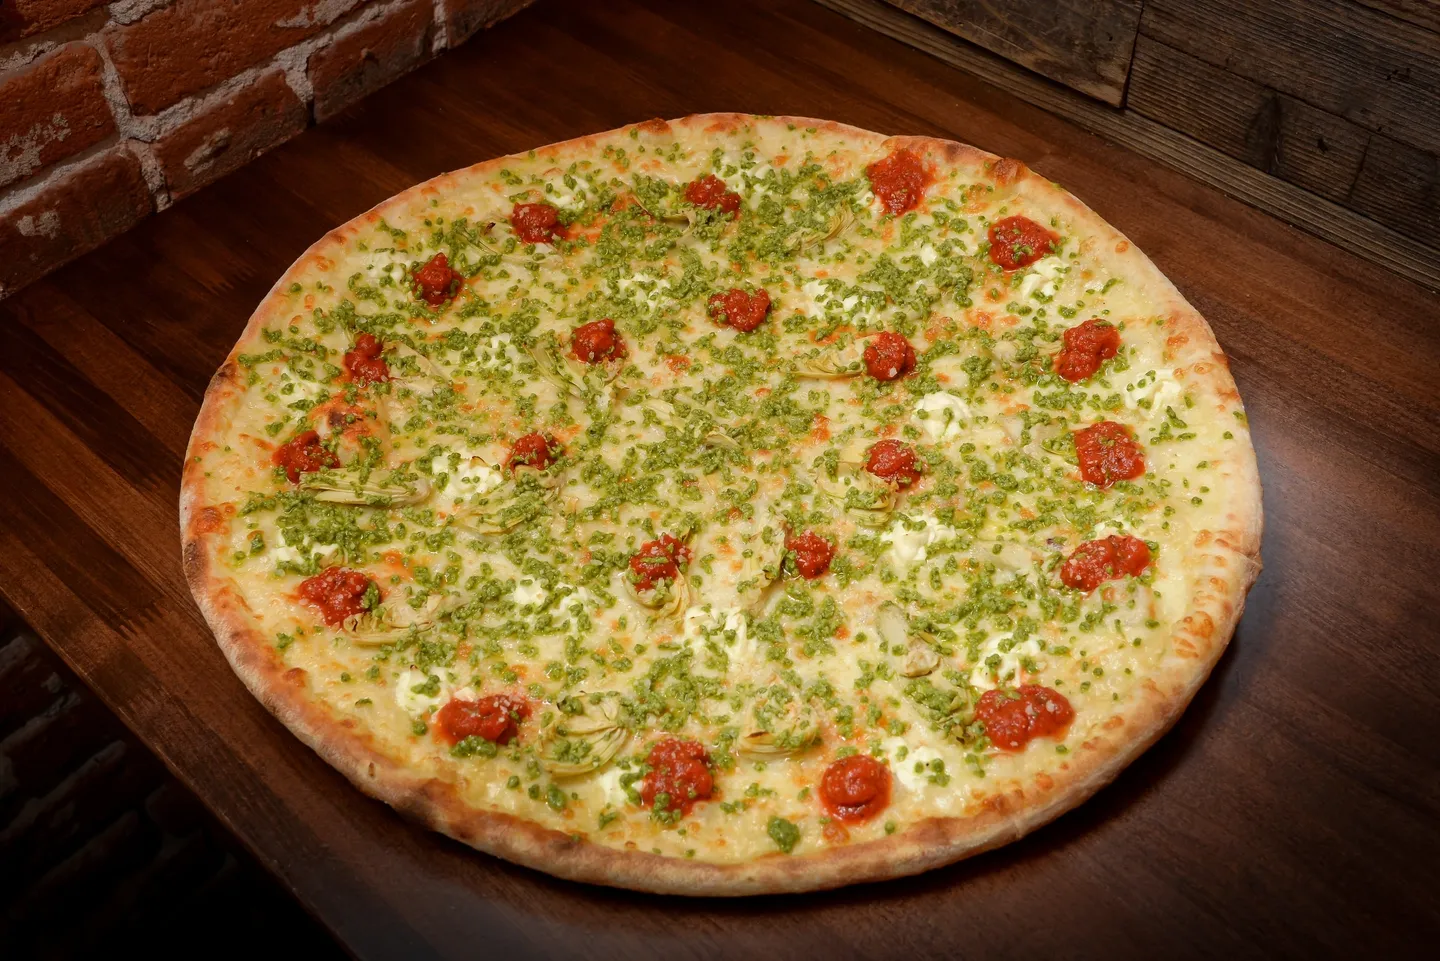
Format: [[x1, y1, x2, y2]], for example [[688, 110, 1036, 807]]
[[180, 114, 1261, 895]]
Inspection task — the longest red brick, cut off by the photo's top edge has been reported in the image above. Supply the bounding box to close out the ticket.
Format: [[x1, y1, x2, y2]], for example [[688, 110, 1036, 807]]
[[107, 0, 359, 114]]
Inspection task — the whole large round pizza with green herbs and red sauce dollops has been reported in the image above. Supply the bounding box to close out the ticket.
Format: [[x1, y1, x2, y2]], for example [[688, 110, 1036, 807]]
[[180, 114, 1261, 895]]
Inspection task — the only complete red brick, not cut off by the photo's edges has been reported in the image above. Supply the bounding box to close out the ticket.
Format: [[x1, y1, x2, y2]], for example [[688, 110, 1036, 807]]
[[156, 71, 307, 200]]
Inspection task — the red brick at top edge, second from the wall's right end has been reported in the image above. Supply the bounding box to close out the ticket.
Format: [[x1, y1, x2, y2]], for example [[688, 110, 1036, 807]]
[[310, 0, 433, 120]]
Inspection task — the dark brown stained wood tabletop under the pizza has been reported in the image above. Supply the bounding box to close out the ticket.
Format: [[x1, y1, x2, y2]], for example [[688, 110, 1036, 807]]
[[0, 0, 1440, 961]]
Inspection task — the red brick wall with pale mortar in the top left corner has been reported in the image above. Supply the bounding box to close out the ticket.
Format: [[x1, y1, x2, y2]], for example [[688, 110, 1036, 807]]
[[0, 0, 530, 298]]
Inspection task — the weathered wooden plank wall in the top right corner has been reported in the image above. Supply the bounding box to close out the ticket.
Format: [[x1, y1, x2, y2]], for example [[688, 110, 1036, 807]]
[[852, 0, 1440, 282]]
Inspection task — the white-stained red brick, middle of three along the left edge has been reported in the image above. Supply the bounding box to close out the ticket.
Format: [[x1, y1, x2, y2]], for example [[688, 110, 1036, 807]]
[[0, 43, 115, 187]]
